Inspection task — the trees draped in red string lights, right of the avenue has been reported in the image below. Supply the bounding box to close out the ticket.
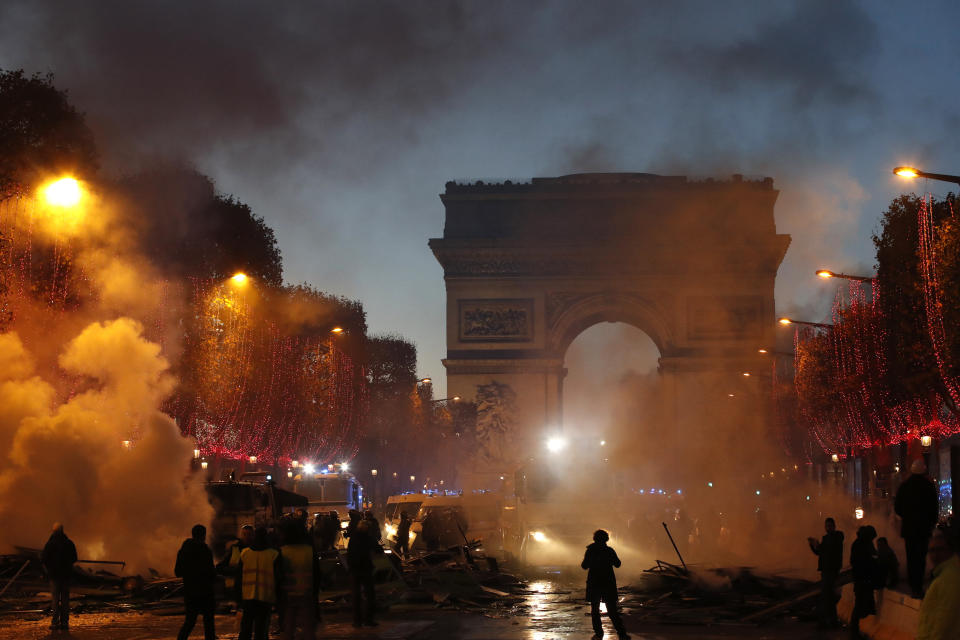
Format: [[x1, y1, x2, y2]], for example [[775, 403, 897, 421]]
[[789, 194, 960, 453]]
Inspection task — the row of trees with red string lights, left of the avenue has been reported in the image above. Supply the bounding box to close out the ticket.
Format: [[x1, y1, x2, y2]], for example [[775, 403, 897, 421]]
[[0, 71, 473, 479]]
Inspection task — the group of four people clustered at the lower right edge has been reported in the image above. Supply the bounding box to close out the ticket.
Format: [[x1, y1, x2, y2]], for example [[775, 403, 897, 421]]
[[808, 459, 960, 640]]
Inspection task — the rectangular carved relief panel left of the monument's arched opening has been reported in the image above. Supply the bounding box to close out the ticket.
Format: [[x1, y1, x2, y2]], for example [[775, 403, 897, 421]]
[[458, 298, 533, 342]]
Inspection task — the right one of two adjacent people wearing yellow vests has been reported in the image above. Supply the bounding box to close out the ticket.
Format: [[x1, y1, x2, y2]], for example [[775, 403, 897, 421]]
[[280, 518, 320, 640]]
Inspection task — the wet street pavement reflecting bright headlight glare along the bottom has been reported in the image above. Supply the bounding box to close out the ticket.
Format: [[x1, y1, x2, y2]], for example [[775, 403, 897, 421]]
[[0, 574, 848, 640]]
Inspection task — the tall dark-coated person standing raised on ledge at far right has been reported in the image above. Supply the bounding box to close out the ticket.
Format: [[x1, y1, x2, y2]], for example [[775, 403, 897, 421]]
[[893, 458, 940, 598]]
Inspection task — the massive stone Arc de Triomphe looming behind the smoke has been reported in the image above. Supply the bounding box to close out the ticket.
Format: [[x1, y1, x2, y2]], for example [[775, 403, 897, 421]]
[[429, 173, 790, 460]]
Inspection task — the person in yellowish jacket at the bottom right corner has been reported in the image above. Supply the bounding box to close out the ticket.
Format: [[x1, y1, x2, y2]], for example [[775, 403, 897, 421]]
[[916, 529, 960, 640]]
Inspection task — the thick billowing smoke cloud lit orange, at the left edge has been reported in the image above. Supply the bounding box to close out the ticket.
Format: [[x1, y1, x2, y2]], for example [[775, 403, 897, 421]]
[[0, 318, 212, 573]]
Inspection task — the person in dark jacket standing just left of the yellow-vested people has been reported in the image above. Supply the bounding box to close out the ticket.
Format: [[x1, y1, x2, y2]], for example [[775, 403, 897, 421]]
[[173, 524, 217, 640]]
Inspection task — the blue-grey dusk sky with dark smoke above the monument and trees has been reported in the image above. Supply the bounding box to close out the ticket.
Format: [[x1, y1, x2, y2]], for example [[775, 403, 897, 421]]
[[0, 0, 960, 393]]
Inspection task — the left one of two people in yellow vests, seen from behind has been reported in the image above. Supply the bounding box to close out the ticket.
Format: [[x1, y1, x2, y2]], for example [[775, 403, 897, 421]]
[[237, 527, 281, 640]]
